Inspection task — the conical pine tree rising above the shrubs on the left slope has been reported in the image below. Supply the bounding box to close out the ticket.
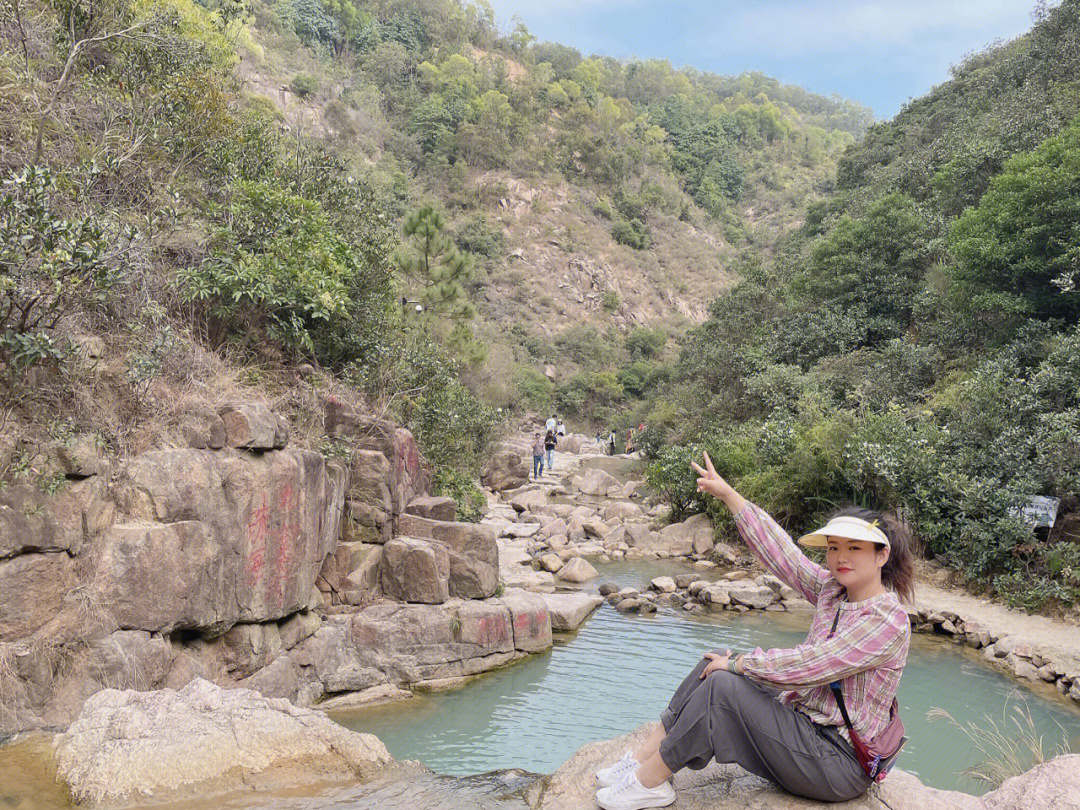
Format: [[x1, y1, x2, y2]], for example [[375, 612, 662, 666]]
[[394, 205, 476, 321]]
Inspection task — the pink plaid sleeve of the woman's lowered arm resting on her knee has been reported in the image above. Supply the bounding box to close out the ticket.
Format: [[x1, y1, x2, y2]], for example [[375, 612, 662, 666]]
[[739, 604, 910, 688]]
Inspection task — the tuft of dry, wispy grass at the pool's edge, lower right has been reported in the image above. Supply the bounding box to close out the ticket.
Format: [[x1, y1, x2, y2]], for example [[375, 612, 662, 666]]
[[927, 690, 1071, 787]]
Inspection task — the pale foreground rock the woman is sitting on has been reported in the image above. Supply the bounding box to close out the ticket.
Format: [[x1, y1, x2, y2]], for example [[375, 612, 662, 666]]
[[532, 724, 984, 810]]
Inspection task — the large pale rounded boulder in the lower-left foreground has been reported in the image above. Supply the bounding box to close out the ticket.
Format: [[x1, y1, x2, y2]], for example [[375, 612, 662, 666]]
[[55, 678, 392, 807]]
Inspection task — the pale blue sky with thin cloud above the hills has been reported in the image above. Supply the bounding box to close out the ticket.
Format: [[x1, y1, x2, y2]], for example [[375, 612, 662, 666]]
[[491, 0, 1035, 118]]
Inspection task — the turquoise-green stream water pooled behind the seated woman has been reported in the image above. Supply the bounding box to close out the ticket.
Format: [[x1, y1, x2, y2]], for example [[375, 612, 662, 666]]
[[335, 561, 1080, 793]]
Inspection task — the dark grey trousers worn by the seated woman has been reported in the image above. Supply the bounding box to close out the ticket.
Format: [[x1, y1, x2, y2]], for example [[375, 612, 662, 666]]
[[660, 650, 872, 801]]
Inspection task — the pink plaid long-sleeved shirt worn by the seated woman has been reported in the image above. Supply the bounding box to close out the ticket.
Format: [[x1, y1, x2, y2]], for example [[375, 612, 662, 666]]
[[735, 502, 912, 742]]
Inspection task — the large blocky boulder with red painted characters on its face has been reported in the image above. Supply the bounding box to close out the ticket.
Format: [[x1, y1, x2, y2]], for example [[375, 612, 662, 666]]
[[103, 449, 345, 632]]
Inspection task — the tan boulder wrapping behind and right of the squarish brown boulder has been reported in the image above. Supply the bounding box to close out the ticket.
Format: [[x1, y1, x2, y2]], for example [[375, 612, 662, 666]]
[[399, 515, 499, 599]]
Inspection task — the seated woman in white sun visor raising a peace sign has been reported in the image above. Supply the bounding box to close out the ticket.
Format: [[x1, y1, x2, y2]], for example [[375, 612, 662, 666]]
[[596, 454, 914, 810]]
